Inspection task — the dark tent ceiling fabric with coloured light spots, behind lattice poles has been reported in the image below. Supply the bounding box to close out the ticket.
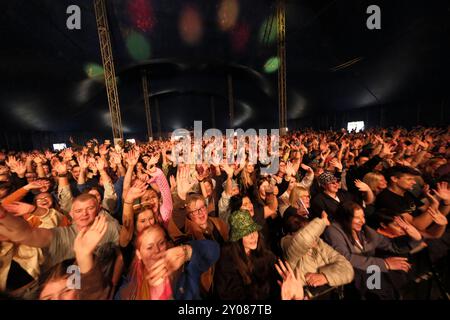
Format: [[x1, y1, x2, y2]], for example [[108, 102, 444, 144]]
[[0, 0, 450, 133]]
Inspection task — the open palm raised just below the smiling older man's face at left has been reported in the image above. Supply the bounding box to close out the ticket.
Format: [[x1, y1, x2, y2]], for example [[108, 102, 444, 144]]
[[73, 214, 108, 256]]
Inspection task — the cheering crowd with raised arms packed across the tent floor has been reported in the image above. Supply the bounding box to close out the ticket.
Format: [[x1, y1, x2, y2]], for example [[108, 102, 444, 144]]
[[0, 127, 450, 300]]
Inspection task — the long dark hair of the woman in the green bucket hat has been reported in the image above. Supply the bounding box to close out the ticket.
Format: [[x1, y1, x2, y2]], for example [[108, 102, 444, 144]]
[[228, 232, 273, 299]]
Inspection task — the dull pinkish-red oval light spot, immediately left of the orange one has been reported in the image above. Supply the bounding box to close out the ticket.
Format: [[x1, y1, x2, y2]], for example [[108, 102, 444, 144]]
[[178, 5, 203, 45]]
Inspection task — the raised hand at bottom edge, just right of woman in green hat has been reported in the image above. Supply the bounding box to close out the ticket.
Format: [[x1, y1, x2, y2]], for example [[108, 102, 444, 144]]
[[275, 259, 304, 300]]
